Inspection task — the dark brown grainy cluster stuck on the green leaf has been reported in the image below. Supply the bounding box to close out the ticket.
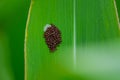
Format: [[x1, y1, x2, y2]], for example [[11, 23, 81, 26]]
[[44, 24, 62, 52]]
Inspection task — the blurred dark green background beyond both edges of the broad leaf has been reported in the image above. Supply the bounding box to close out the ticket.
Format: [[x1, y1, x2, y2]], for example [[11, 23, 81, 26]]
[[0, 0, 120, 80]]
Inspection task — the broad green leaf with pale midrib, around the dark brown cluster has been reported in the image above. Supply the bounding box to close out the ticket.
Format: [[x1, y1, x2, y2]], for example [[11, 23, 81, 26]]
[[25, 0, 120, 80]]
